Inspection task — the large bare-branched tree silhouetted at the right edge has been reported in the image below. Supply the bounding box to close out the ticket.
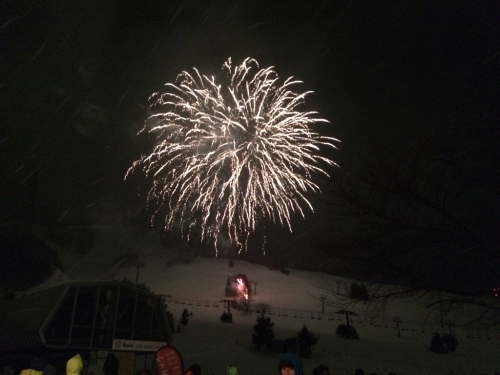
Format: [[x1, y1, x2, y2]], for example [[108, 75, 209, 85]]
[[323, 103, 500, 324]]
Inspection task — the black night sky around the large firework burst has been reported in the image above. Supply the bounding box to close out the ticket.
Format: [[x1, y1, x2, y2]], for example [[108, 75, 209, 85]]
[[0, 0, 500, 258]]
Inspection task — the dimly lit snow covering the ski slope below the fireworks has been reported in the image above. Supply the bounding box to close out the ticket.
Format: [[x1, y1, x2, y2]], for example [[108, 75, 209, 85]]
[[34, 250, 500, 375]]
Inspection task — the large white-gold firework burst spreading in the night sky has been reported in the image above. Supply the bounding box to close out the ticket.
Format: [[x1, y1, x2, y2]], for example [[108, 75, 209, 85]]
[[125, 58, 337, 251]]
